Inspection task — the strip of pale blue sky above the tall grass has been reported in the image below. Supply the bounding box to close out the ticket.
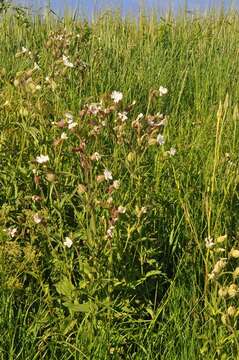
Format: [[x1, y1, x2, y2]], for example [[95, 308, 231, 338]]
[[15, 0, 239, 15]]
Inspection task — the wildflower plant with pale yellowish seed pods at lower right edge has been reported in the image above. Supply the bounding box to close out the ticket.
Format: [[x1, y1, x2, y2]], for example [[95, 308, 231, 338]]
[[205, 235, 239, 348]]
